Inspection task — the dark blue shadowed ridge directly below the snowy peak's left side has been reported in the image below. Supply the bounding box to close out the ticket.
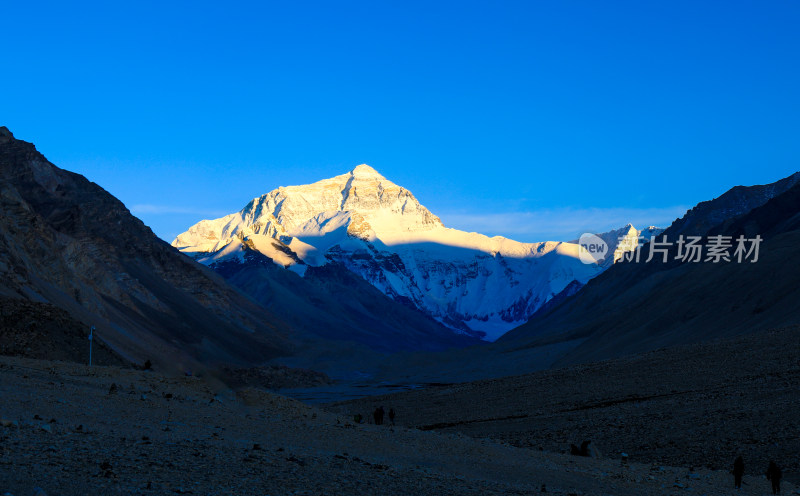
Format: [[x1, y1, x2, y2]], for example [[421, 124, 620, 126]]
[[212, 251, 480, 353]]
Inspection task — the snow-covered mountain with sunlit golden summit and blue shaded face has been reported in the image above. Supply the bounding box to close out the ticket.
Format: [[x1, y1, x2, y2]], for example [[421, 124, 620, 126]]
[[177, 165, 640, 339]]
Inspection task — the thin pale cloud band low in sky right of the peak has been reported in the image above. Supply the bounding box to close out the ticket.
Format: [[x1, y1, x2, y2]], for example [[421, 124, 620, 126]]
[[439, 205, 689, 242]]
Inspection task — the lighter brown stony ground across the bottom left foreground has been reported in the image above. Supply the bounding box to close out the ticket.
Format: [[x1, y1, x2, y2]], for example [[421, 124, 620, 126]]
[[0, 357, 795, 496]]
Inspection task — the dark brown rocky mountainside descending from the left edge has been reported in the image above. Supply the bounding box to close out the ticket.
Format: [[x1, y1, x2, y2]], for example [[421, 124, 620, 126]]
[[0, 128, 290, 367]]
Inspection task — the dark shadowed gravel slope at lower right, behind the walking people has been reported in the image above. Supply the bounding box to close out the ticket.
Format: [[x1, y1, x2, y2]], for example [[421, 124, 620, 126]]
[[326, 327, 800, 487]]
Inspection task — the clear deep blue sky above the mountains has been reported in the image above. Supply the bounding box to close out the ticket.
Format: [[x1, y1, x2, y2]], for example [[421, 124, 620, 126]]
[[0, 1, 800, 241]]
